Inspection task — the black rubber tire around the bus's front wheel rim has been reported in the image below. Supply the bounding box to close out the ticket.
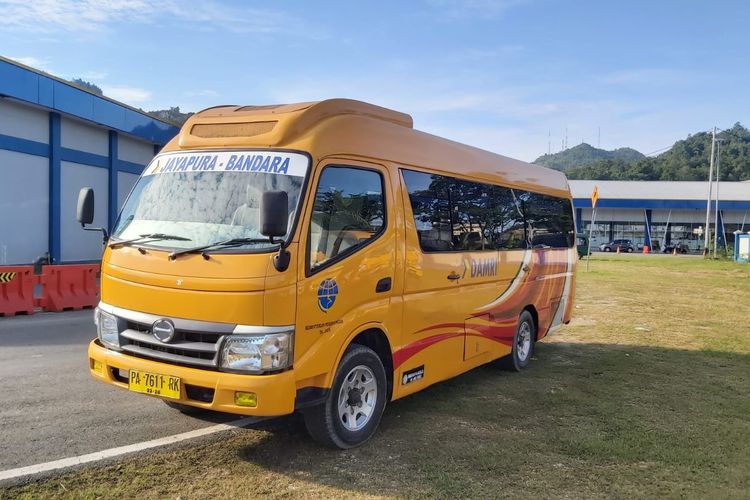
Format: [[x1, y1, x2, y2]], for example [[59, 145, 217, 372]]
[[303, 344, 387, 450]]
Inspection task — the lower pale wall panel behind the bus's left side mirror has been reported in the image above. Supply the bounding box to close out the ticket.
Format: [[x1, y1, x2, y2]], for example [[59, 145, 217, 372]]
[[60, 161, 109, 261]]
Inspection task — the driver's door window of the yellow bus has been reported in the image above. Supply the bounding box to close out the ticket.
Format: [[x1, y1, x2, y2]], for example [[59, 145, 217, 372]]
[[310, 167, 385, 269]]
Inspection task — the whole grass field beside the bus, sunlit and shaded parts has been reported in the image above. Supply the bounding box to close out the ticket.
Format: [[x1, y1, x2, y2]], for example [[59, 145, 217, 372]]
[[0, 255, 750, 499]]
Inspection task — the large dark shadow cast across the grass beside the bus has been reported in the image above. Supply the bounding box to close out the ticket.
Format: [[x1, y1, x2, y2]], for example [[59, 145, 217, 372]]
[[238, 343, 750, 496]]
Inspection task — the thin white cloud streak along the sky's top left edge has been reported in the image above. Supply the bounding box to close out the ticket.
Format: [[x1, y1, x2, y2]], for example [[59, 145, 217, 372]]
[[0, 0, 322, 37]]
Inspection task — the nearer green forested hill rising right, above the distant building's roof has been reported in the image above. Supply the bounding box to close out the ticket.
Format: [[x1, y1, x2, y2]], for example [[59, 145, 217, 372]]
[[565, 123, 750, 181]]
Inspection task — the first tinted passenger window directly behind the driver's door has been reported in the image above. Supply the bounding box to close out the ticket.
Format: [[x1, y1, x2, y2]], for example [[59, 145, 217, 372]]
[[402, 170, 455, 252]]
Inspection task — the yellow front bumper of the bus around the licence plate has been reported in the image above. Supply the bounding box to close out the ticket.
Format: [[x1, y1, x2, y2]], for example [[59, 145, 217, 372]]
[[88, 340, 296, 417]]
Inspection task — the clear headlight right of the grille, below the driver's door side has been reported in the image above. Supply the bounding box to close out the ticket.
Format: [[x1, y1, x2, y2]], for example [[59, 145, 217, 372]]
[[220, 331, 294, 373]]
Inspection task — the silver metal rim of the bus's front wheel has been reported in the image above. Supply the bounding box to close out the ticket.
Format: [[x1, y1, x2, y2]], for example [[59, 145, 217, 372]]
[[338, 365, 378, 431]]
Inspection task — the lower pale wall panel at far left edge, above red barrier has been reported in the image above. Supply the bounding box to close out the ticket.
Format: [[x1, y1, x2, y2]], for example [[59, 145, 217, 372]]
[[0, 149, 49, 265]]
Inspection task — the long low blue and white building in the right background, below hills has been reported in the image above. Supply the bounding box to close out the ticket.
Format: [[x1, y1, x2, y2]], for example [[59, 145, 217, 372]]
[[570, 180, 750, 252]]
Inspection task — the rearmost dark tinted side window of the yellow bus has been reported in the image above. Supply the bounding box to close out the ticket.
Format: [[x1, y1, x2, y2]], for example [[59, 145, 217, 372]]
[[520, 193, 575, 248]]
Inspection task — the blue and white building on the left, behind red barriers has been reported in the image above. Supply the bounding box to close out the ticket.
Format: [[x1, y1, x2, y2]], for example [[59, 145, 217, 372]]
[[0, 58, 178, 265]]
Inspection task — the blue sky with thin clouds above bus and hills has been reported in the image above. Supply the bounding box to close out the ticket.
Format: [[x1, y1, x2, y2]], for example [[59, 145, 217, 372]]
[[0, 0, 750, 160]]
